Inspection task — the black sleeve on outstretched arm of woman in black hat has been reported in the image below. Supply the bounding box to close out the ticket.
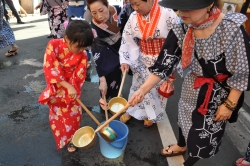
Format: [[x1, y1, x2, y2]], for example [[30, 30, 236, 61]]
[[149, 30, 181, 80]]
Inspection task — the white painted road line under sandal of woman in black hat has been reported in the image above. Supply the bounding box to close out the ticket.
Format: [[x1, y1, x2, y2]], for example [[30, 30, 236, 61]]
[[157, 111, 184, 166]]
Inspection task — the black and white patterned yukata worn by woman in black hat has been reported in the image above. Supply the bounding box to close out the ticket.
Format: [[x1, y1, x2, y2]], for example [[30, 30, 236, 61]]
[[149, 13, 250, 158]]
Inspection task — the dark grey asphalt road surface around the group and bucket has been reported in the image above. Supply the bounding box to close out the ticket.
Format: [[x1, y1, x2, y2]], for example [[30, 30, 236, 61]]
[[0, 15, 249, 166]]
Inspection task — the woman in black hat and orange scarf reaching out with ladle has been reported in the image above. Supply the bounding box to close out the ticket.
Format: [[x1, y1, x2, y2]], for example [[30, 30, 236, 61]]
[[129, 0, 250, 166]]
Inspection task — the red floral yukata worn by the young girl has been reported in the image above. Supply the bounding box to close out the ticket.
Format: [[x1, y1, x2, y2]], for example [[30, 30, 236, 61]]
[[38, 39, 88, 150]]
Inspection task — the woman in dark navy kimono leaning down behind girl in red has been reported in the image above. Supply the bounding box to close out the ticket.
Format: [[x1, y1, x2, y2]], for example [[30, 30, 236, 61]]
[[87, 0, 125, 108]]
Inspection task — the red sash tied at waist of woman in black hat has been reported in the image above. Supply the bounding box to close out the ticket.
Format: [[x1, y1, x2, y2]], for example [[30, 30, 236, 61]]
[[194, 74, 228, 115]]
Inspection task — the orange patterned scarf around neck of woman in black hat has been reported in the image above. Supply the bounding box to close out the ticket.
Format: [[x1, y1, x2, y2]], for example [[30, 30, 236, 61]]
[[181, 7, 220, 69]]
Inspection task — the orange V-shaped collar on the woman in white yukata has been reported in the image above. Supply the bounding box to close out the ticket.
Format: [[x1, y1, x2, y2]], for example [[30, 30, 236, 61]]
[[136, 0, 161, 40]]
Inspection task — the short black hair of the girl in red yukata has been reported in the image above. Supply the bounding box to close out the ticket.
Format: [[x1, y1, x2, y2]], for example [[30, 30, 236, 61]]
[[65, 20, 94, 48]]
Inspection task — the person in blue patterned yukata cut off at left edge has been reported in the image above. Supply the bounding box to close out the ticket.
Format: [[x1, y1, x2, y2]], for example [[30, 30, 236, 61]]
[[0, 0, 18, 57]]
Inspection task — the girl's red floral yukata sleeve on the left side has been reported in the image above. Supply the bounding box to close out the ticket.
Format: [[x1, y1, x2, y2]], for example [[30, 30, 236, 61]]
[[43, 40, 65, 84]]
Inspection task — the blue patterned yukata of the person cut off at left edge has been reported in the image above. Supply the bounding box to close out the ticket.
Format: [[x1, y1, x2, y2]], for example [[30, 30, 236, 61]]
[[0, 0, 16, 48]]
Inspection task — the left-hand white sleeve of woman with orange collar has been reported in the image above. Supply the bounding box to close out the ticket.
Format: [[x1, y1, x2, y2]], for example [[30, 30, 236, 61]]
[[119, 15, 140, 70]]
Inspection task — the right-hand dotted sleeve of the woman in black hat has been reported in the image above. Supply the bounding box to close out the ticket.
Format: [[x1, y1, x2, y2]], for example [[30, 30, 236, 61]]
[[225, 26, 250, 91]]
